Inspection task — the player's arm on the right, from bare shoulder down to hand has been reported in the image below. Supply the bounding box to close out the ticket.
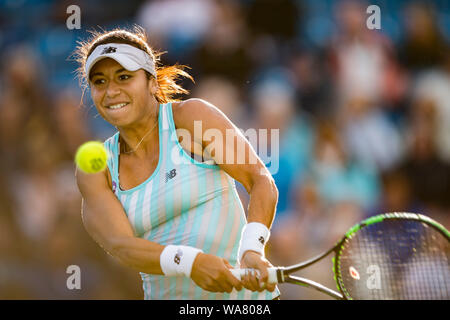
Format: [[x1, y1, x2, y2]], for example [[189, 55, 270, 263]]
[[174, 99, 278, 290]]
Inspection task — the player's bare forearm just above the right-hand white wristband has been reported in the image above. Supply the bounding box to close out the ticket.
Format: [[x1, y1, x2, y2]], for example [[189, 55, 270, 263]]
[[247, 174, 278, 229]]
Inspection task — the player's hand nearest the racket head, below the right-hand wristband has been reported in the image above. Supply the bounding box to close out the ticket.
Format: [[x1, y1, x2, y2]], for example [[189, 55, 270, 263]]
[[240, 251, 276, 292]]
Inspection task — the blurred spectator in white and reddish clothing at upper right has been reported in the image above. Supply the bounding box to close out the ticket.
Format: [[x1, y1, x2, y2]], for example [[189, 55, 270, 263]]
[[329, 0, 404, 107]]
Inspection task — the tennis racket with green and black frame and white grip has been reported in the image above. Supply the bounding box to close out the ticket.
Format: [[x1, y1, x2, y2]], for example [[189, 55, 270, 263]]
[[232, 212, 450, 300]]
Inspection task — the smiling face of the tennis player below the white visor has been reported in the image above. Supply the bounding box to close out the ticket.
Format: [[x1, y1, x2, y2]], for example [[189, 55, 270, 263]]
[[89, 58, 156, 127]]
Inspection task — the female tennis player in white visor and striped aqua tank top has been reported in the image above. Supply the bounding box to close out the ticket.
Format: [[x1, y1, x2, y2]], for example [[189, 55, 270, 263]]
[[76, 28, 279, 299]]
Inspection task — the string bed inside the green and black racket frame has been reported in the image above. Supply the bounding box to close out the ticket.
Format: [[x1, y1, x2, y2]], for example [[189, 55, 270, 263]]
[[337, 220, 450, 300]]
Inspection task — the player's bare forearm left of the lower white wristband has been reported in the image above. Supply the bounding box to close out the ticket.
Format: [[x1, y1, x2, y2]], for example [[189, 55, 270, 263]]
[[107, 237, 164, 275]]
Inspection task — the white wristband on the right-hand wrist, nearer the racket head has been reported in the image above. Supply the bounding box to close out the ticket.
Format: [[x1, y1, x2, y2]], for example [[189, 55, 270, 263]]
[[238, 222, 270, 261]]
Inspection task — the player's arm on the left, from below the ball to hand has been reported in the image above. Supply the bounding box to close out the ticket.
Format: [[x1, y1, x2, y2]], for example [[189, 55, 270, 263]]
[[76, 165, 242, 292]]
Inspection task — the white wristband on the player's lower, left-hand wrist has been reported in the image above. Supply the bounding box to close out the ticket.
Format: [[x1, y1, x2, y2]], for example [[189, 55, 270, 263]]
[[159, 245, 203, 278]]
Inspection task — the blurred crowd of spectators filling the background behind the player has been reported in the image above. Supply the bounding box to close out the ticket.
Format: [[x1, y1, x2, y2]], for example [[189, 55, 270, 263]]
[[0, 0, 450, 299]]
